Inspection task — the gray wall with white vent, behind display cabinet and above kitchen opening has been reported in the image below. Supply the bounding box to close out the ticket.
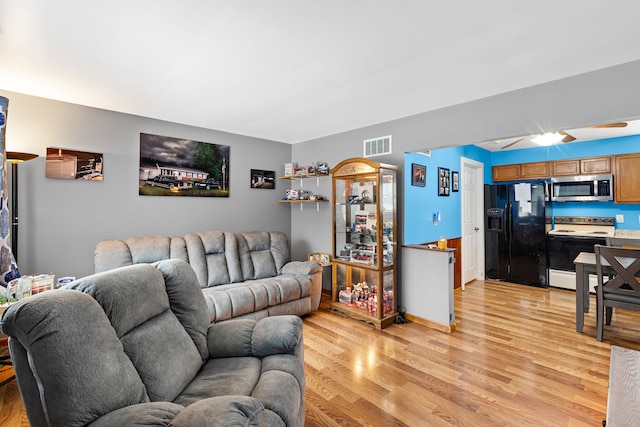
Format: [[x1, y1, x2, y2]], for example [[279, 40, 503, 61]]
[[291, 61, 640, 257]]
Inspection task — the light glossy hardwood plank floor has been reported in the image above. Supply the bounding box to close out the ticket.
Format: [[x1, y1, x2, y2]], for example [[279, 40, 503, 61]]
[[0, 281, 640, 427]]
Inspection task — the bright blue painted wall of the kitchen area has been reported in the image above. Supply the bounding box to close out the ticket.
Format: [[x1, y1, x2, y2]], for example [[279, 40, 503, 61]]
[[403, 135, 640, 245]]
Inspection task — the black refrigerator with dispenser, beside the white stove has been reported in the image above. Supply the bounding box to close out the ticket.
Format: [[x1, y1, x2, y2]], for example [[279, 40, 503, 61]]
[[484, 182, 549, 288]]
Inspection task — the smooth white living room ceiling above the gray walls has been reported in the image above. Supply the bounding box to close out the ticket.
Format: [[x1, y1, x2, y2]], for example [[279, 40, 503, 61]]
[[0, 0, 640, 143]]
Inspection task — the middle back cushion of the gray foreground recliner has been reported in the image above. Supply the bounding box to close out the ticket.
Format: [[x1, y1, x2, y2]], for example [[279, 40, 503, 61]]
[[67, 260, 206, 401]]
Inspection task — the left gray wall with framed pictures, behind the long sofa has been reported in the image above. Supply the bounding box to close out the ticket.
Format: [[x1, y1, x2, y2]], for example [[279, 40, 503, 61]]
[[0, 90, 292, 277]]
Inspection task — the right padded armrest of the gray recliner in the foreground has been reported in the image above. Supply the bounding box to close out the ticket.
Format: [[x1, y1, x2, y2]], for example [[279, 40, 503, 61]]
[[207, 316, 302, 358]]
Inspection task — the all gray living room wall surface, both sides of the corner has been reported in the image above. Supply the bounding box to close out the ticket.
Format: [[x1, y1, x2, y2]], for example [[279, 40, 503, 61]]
[[5, 61, 640, 277]]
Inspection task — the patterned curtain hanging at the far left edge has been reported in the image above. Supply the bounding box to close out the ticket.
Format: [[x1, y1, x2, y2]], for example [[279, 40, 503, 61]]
[[0, 96, 20, 291]]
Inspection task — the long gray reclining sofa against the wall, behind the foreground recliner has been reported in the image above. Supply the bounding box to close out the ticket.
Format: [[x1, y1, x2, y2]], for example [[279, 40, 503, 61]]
[[94, 231, 322, 323]]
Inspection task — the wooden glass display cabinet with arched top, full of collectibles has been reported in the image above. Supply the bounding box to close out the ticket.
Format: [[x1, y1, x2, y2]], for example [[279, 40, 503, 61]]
[[331, 158, 398, 329]]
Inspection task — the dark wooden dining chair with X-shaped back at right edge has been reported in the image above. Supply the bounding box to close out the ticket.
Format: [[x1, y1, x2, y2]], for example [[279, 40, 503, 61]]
[[594, 245, 640, 341]]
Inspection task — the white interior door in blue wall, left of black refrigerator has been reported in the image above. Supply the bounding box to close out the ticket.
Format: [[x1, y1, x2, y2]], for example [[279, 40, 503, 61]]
[[460, 157, 484, 289]]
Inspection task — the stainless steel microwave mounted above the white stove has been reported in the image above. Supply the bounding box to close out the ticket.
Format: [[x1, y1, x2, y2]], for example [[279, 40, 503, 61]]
[[551, 174, 613, 202]]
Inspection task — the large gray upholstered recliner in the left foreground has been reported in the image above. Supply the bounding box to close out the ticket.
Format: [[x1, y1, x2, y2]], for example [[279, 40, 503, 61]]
[[0, 260, 305, 427]]
